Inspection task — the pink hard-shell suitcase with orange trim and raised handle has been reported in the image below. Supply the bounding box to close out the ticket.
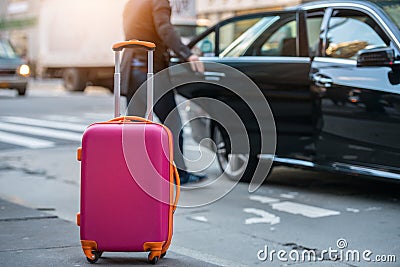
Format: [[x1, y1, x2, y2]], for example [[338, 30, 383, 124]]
[[77, 40, 180, 264]]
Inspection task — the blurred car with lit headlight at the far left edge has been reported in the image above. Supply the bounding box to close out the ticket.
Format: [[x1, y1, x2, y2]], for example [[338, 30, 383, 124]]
[[0, 38, 30, 96]]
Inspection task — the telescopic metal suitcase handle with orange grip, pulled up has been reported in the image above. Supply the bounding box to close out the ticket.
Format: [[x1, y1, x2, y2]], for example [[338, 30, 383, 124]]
[[112, 40, 156, 121]]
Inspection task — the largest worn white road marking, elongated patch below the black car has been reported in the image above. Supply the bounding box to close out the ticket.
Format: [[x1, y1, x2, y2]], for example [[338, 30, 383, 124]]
[[271, 201, 340, 218]]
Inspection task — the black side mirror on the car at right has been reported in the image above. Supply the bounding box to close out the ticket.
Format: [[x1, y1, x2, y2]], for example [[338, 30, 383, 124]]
[[357, 47, 395, 67]]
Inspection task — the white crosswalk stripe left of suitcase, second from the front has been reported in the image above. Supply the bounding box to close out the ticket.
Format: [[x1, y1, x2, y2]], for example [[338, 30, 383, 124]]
[[0, 122, 82, 141]]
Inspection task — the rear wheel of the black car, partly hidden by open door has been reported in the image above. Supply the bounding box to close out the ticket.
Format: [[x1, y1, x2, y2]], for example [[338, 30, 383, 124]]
[[213, 125, 259, 182]]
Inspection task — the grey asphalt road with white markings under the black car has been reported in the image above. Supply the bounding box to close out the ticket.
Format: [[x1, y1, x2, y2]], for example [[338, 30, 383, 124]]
[[0, 81, 400, 266]]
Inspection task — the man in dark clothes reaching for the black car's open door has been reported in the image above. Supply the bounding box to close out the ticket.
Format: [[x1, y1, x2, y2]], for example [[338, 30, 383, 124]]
[[121, 0, 206, 184]]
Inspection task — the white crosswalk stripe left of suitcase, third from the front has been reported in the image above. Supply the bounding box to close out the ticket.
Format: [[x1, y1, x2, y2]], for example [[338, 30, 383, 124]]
[[1, 116, 87, 133]]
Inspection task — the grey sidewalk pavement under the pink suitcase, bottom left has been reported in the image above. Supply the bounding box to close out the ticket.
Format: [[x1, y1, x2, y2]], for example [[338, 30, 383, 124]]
[[0, 199, 216, 267]]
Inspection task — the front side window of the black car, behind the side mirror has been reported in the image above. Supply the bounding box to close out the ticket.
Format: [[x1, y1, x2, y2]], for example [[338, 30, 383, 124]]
[[325, 10, 389, 60]]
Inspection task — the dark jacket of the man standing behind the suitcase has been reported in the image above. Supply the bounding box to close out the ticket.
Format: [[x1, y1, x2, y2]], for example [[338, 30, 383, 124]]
[[121, 0, 191, 95]]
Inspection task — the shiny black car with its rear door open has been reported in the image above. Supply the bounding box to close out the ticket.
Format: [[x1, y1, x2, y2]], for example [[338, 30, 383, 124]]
[[172, 0, 400, 180]]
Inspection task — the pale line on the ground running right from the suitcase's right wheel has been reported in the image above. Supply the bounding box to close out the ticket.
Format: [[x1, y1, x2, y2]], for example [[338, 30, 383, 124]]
[[169, 245, 247, 267]]
